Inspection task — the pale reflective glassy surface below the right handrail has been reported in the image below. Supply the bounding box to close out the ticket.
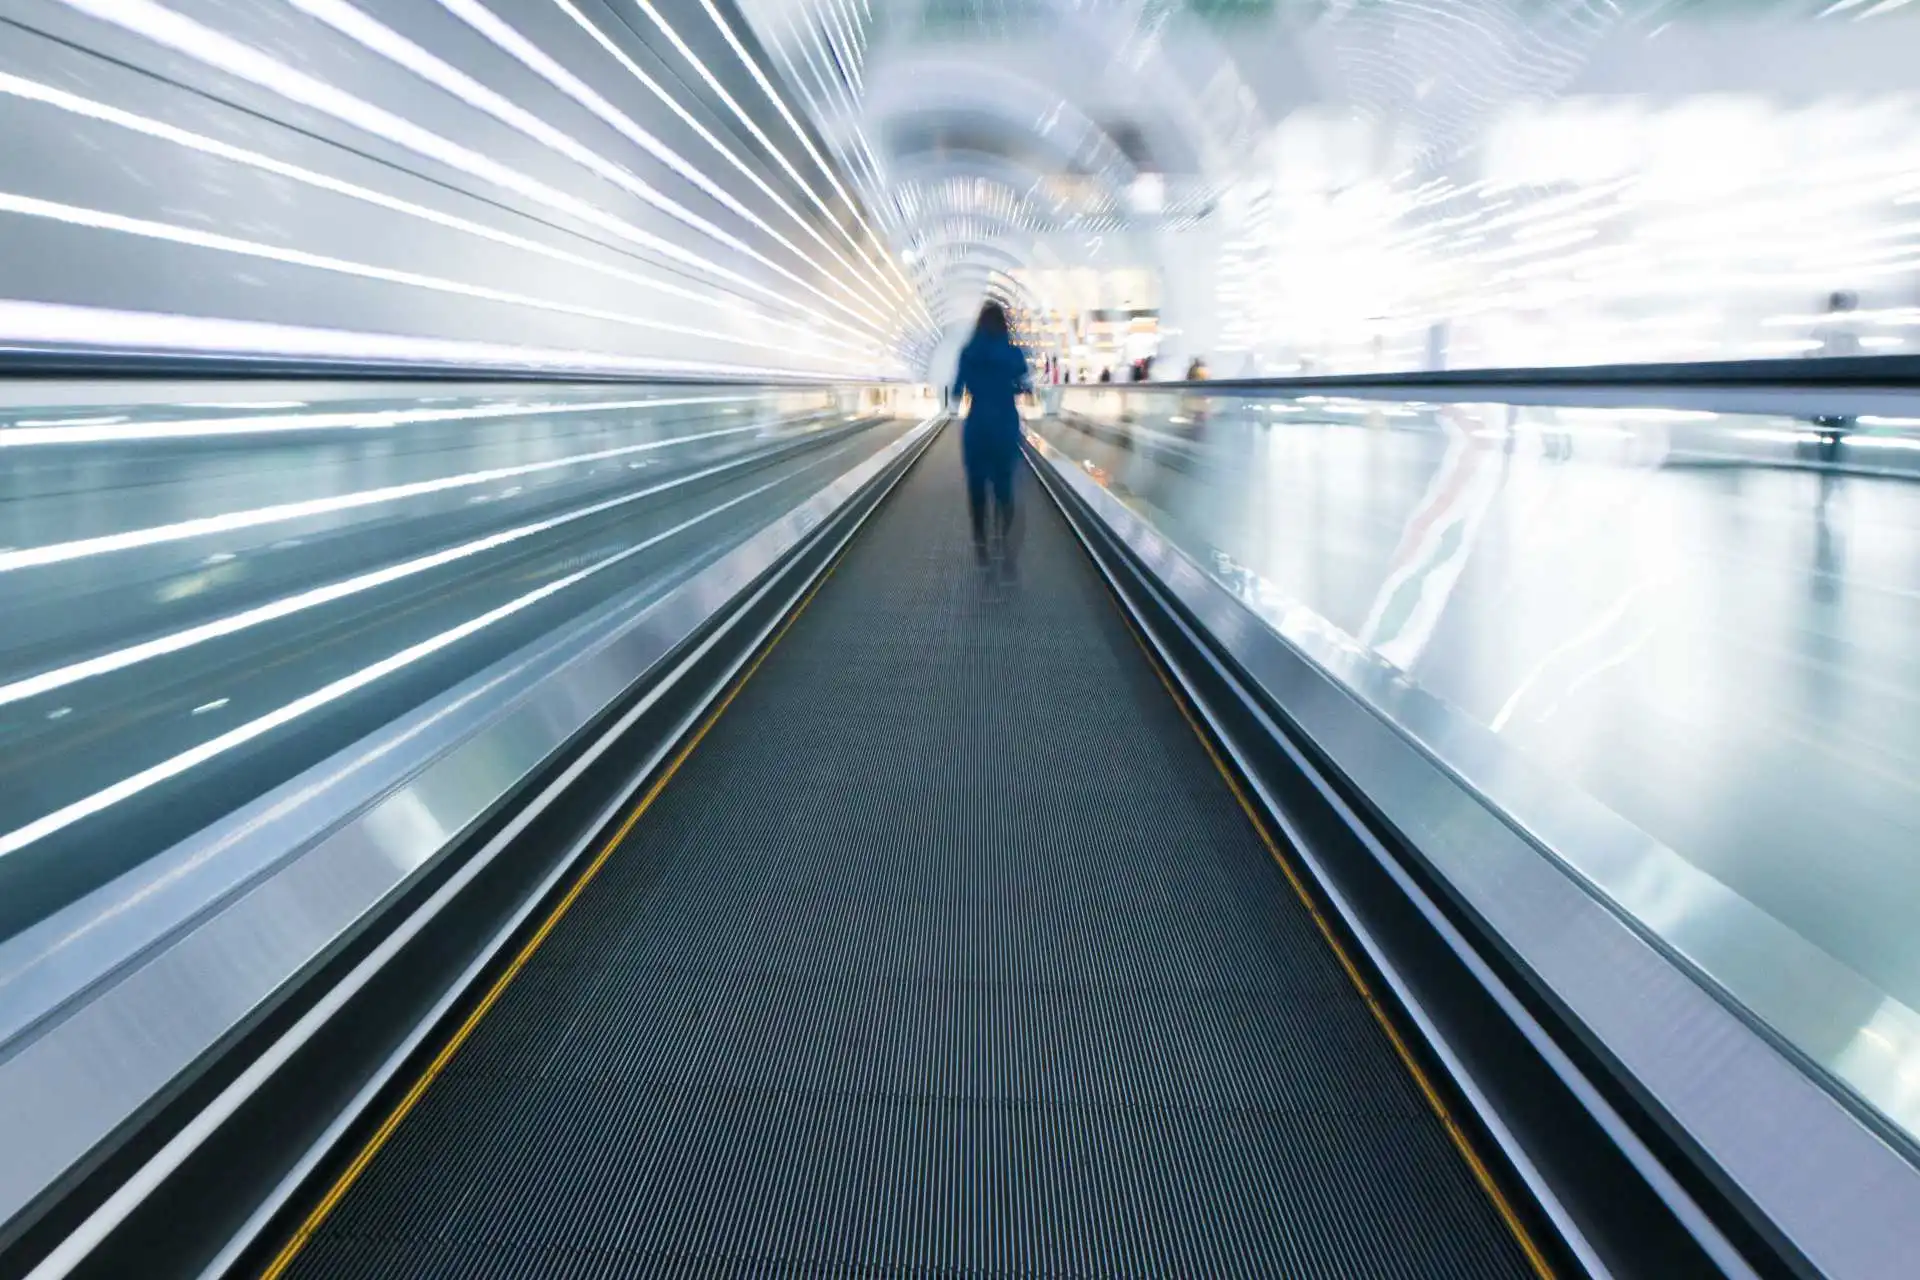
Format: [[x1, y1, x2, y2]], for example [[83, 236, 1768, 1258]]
[[1039, 395, 1920, 1125]]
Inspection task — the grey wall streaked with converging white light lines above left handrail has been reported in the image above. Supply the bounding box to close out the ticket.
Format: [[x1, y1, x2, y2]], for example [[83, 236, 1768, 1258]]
[[0, 0, 935, 378]]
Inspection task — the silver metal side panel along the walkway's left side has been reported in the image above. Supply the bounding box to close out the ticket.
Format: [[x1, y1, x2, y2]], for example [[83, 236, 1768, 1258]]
[[0, 418, 935, 1230]]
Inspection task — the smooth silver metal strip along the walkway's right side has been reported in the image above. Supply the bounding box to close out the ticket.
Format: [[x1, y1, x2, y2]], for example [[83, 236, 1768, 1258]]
[[1029, 436, 1920, 1280]]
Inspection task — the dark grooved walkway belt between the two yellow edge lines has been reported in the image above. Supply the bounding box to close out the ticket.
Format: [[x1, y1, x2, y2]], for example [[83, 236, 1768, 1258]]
[[269, 432, 1544, 1280]]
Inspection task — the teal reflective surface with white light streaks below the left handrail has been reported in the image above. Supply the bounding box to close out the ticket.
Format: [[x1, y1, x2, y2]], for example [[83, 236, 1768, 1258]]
[[0, 388, 921, 938]]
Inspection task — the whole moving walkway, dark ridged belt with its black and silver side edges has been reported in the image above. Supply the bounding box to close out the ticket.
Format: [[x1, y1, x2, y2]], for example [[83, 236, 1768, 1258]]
[[0, 383, 1908, 1278]]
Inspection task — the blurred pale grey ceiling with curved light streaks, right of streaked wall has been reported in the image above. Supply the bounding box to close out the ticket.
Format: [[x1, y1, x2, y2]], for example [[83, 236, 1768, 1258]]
[[739, 0, 1920, 370]]
